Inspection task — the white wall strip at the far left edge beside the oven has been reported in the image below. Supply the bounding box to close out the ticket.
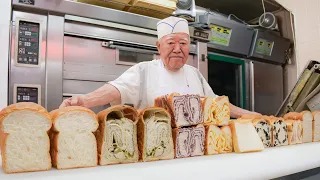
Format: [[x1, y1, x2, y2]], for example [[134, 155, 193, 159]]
[[0, 0, 11, 109]]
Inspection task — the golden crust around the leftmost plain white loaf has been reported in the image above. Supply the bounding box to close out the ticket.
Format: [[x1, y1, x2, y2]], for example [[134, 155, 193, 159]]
[[0, 102, 52, 174]]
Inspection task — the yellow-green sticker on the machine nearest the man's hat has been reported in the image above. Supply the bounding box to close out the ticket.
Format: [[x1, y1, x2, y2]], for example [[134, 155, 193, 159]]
[[210, 24, 232, 46]]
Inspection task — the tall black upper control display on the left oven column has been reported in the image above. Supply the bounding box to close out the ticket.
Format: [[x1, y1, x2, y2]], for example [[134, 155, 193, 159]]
[[17, 21, 40, 65]]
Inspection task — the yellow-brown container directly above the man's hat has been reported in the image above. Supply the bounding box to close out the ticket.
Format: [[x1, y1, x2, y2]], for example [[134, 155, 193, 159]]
[[126, 0, 178, 19]]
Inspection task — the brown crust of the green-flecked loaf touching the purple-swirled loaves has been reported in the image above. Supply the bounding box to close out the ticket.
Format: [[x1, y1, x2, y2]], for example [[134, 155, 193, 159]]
[[137, 106, 174, 161]]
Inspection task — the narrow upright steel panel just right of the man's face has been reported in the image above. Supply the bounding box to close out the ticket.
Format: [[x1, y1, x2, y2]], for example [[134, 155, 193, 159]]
[[197, 41, 208, 81]]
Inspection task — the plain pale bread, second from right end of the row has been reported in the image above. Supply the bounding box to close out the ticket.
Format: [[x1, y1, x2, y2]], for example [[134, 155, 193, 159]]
[[301, 111, 313, 143]]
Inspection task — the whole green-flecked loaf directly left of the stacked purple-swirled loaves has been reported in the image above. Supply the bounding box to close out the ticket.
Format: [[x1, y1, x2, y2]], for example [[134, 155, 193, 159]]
[[138, 107, 174, 162]]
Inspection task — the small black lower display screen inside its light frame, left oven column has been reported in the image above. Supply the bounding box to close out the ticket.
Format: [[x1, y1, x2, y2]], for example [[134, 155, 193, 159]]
[[16, 87, 38, 103]]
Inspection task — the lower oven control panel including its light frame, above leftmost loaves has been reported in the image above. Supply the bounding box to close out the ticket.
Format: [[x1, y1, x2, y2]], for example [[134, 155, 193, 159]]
[[13, 84, 41, 104]]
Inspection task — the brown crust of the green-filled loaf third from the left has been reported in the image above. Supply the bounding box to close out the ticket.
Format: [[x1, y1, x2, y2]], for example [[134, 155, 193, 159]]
[[94, 105, 140, 165]]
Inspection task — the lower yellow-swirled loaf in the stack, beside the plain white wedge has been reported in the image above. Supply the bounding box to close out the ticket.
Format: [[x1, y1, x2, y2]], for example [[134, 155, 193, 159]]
[[205, 125, 233, 155]]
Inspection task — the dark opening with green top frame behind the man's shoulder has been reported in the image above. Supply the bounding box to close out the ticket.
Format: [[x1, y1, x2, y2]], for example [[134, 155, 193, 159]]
[[208, 55, 245, 107]]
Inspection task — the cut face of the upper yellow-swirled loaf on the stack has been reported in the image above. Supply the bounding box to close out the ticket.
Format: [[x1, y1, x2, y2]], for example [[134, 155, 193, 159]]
[[212, 96, 230, 126]]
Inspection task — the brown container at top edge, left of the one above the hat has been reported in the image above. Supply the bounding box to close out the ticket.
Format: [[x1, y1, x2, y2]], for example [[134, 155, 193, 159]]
[[77, 0, 131, 10]]
